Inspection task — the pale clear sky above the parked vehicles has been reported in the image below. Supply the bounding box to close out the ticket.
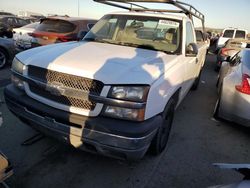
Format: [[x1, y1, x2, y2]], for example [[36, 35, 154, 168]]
[[0, 0, 250, 32]]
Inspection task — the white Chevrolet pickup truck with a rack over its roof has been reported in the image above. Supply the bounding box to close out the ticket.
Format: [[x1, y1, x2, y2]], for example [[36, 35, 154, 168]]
[[4, 0, 207, 160]]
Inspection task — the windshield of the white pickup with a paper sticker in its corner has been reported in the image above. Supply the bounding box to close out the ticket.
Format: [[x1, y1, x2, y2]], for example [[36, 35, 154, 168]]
[[84, 15, 181, 54]]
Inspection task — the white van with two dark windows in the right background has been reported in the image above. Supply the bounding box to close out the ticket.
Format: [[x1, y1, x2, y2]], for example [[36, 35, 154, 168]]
[[217, 28, 248, 50]]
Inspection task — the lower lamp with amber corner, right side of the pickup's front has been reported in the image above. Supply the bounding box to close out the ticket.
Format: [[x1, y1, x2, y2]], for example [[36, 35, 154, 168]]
[[104, 106, 145, 121]]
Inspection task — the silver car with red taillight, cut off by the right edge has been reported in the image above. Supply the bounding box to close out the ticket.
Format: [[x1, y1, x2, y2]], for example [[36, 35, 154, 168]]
[[214, 49, 250, 126]]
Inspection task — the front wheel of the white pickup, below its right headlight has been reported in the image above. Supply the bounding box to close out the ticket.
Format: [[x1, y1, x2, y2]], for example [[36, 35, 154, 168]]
[[150, 99, 175, 155]]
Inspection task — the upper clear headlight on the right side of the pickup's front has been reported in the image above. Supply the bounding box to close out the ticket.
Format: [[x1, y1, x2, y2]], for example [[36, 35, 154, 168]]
[[109, 86, 149, 102]]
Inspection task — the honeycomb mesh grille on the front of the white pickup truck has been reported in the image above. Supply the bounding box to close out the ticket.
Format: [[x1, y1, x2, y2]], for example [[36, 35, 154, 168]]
[[28, 66, 104, 110]]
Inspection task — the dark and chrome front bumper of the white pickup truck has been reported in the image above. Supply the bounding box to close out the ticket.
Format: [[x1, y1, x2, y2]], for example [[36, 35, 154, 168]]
[[4, 84, 162, 160]]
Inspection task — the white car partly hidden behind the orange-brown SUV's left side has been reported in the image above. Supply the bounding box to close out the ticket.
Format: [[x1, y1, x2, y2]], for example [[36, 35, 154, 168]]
[[13, 22, 39, 50]]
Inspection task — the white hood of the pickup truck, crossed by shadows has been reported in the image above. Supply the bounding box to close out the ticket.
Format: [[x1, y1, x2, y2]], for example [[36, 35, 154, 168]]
[[17, 41, 177, 84]]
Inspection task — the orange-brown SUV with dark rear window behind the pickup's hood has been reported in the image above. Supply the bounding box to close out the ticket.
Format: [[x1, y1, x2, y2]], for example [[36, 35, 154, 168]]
[[32, 16, 97, 47]]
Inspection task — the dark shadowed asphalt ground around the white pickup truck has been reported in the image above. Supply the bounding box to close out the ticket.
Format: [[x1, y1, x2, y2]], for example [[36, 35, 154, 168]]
[[0, 55, 250, 188]]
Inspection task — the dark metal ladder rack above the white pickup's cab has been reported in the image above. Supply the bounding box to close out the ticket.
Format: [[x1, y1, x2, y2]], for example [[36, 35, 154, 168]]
[[94, 0, 205, 31]]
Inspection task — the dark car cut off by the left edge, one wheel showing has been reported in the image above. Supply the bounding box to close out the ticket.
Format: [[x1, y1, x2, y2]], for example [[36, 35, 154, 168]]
[[0, 37, 16, 68]]
